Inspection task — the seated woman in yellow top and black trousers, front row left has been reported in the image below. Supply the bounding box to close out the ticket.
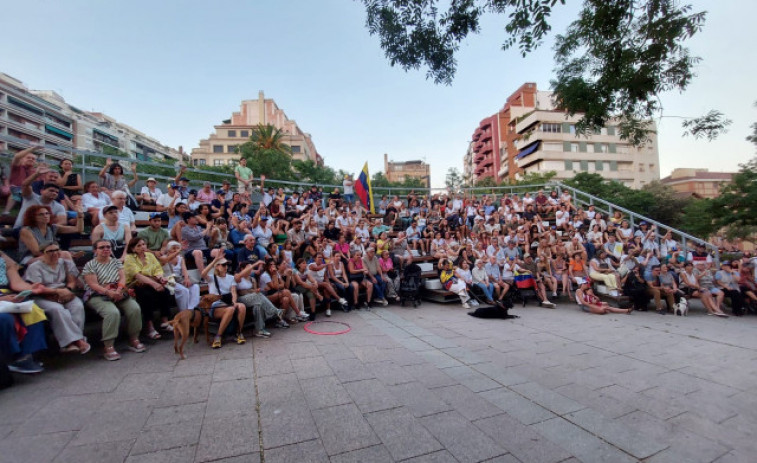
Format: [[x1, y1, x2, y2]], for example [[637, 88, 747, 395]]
[[124, 237, 176, 340]]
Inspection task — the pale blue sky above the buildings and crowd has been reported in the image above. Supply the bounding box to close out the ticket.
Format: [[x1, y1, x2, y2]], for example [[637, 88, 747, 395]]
[[0, 0, 757, 187]]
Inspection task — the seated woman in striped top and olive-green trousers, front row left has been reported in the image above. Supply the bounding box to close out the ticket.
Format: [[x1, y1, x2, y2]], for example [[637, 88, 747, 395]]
[[82, 240, 146, 361]]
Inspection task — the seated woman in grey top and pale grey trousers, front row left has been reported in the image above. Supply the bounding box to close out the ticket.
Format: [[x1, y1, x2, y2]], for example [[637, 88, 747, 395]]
[[24, 242, 90, 354]]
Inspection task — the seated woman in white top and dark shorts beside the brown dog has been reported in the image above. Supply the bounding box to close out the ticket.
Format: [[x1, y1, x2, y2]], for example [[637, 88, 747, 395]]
[[201, 254, 247, 349]]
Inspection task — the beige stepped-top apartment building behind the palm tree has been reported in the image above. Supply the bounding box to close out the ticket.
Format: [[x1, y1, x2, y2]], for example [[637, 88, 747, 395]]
[[191, 91, 323, 166]]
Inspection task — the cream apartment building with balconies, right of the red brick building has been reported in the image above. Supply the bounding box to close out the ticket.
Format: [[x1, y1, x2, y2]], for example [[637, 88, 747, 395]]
[[510, 92, 660, 188]]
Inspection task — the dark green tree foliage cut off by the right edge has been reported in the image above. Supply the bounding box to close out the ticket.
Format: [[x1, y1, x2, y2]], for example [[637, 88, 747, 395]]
[[712, 158, 757, 243]]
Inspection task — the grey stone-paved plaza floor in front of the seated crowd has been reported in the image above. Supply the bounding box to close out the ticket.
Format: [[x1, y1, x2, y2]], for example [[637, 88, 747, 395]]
[[0, 303, 757, 463]]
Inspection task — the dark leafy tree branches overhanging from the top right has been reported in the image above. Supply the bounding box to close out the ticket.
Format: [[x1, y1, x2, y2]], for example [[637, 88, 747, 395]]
[[361, 0, 727, 145]]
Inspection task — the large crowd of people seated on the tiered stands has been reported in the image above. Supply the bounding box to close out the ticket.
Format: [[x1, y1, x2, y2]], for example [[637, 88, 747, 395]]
[[0, 148, 757, 380]]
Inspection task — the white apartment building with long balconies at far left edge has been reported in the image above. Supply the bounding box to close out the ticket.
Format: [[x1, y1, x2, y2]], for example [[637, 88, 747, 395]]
[[0, 73, 76, 159]]
